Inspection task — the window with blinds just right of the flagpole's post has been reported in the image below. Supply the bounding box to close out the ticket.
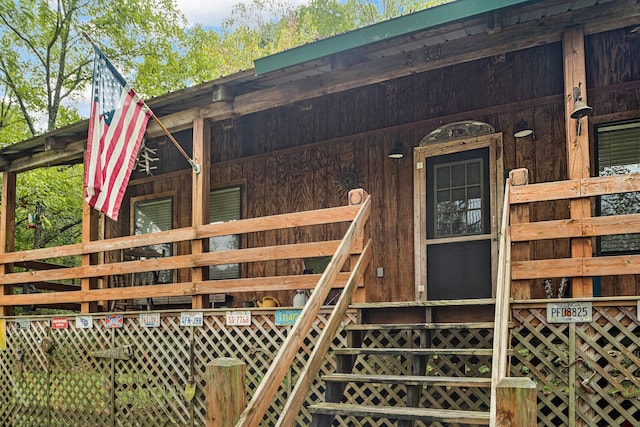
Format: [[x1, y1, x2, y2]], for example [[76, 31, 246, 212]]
[[209, 187, 240, 280]]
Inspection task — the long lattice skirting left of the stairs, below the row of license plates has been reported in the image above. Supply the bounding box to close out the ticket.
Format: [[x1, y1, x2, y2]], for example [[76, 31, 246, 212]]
[[0, 310, 356, 427]]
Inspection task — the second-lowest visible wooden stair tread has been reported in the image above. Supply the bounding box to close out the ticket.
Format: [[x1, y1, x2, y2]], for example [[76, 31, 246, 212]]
[[322, 374, 491, 387]]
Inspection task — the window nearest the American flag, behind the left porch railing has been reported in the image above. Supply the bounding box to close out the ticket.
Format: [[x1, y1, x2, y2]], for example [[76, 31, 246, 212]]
[[133, 197, 173, 283]]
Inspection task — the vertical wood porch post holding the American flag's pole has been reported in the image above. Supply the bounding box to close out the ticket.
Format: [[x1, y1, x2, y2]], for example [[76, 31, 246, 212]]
[[191, 117, 211, 308]]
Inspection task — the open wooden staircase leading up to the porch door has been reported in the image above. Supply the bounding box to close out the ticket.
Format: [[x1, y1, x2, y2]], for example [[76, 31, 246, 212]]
[[309, 299, 495, 427]]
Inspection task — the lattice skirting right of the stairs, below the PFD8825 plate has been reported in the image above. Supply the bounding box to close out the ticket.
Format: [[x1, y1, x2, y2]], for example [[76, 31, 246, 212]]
[[511, 305, 640, 426]]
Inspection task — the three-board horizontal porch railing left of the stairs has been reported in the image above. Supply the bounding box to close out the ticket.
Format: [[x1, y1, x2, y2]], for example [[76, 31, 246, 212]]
[[0, 189, 368, 308]]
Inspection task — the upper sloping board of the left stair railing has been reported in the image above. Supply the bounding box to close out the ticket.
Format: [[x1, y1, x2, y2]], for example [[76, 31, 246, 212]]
[[236, 196, 371, 427]]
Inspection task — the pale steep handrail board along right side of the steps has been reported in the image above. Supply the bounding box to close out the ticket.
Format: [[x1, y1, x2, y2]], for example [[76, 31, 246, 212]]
[[489, 179, 511, 426]]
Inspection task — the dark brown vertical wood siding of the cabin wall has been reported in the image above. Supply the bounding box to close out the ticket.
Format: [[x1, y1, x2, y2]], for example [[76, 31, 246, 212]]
[[107, 28, 640, 303]]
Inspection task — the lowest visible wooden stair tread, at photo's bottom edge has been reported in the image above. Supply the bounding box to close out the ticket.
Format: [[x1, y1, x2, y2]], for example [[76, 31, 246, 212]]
[[309, 403, 489, 425]]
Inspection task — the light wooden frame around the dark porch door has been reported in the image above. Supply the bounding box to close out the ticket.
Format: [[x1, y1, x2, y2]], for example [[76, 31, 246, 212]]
[[413, 133, 505, 301]]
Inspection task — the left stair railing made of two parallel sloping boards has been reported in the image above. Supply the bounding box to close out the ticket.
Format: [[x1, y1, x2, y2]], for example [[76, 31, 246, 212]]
[[236, 190, 371, 427]]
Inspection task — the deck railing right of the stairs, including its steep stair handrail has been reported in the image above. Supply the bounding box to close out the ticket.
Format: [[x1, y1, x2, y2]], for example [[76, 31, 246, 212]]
[[490, 170, 640, 425]]
